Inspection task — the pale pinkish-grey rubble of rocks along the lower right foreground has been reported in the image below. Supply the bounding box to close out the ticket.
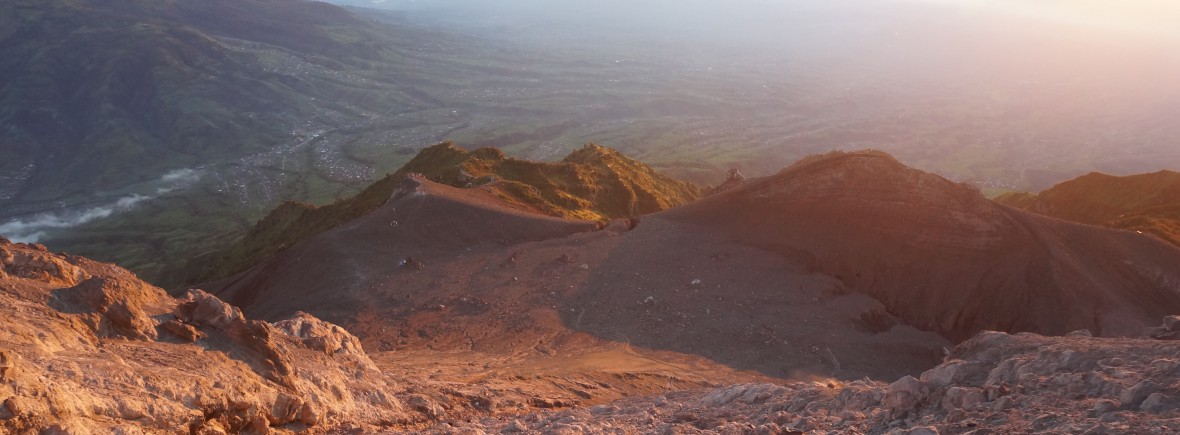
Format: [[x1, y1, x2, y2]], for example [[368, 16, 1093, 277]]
[[431, 331, 1180, 435]]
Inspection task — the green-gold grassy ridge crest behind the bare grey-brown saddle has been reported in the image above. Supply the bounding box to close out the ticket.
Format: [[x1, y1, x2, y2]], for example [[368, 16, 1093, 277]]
[[186, 143, 702, 282]]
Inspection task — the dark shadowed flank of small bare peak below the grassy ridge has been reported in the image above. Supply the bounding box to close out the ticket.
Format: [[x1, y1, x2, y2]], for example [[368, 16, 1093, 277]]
[[207, 177, 596, 318]]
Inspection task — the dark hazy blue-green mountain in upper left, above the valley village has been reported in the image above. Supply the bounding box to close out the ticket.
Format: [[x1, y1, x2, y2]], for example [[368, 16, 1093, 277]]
[[0, 0, 410, 206]]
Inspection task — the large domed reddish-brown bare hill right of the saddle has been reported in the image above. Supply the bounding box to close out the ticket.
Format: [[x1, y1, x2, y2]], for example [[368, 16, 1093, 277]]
[[668, 152, 1180, 340]]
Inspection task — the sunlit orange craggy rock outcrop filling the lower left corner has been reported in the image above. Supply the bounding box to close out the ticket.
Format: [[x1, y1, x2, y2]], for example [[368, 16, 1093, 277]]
[[0, 236, 406, 434]]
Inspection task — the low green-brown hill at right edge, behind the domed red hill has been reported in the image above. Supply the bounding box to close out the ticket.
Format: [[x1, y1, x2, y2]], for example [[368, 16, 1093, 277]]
[[996, 171, 1180, 245]]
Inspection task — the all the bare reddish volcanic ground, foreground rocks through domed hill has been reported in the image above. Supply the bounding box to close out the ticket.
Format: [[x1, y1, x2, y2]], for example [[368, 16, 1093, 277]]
[[0, 152, 1180, 434]]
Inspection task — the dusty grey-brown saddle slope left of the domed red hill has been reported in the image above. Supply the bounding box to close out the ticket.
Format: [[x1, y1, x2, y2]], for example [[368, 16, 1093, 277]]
[[207, 173, 948, 377]]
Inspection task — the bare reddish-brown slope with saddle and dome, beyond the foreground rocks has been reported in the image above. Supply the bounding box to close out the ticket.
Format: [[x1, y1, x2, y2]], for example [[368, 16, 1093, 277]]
[[208, 152, 1180, 378]]
